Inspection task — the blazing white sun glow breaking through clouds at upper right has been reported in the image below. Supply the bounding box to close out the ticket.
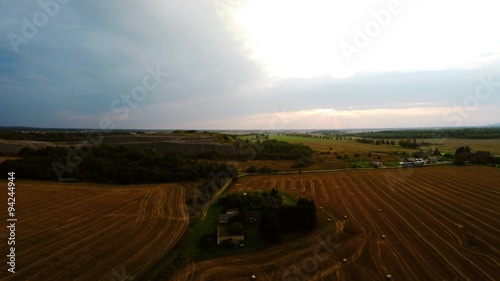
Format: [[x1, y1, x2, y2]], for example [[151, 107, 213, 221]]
[[235, 0, 500, 78]]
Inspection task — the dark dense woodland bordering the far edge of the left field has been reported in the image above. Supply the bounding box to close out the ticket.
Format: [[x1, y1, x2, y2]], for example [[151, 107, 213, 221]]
[[0, 145, 237, 184]]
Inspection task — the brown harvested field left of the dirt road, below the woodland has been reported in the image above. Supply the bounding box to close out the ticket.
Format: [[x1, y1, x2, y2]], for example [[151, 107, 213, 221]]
[[0, 180, 189, 281]]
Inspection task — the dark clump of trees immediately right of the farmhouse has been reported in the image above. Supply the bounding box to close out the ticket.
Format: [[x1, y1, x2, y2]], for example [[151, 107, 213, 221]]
[[259, 188, 317, 242]]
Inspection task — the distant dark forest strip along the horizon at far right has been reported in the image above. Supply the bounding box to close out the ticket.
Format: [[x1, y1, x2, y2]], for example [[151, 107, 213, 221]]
[[351, 127, 500, 139]]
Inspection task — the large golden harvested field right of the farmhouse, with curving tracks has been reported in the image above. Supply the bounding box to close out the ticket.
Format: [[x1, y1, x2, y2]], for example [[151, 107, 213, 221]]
[[172, 166, 500, 281]]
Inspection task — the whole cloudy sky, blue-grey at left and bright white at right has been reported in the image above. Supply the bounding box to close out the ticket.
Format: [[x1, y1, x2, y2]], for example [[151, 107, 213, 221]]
[[0, 0, 500, 130]]
